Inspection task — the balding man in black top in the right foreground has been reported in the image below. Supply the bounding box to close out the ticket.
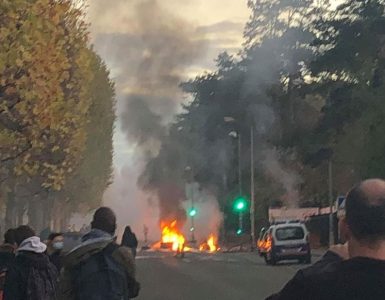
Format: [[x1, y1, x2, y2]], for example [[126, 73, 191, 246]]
[[268, 179, 385, 300]]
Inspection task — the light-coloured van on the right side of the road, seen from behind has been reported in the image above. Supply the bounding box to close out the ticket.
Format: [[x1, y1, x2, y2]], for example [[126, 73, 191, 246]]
[[258, 221, 311, 265]]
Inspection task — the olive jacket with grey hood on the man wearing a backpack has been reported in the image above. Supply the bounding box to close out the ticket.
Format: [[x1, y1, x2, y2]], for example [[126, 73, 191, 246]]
[[59, 229, 135, 300]]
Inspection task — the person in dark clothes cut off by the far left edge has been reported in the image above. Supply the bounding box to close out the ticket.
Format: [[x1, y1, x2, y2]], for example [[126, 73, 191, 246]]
[[0, 228, 16, 300]]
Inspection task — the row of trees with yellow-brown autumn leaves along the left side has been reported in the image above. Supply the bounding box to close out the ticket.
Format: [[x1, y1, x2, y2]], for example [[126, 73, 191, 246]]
[[0, 0, 115, 230]]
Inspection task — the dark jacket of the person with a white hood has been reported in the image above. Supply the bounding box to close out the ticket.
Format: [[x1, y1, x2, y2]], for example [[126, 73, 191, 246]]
[[4, 251, 58, 300]]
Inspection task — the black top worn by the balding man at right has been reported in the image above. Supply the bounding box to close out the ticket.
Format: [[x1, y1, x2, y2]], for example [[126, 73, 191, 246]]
[[271, 257, 385, 300]]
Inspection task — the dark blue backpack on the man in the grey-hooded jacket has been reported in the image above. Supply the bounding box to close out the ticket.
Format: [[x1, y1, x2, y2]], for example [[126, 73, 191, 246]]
[[71, 243, 136, 300]]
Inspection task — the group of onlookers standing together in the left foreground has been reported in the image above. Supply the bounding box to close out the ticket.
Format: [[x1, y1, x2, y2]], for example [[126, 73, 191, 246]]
[[0, 207, 140, 300]]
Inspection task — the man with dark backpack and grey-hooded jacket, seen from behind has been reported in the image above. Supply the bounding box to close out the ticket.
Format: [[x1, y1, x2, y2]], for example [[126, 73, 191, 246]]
[[59, 207, 140, 300]]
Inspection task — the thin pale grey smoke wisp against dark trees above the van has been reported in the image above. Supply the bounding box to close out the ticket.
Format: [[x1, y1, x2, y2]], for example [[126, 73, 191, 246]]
[[243, 38, 302, 207]]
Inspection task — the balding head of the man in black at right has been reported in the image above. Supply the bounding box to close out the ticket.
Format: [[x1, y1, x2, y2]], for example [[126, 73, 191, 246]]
[[340, 179, 385, 253]]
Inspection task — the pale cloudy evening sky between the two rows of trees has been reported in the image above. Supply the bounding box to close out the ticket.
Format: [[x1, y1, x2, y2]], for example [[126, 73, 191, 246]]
[[87, 0, 249, 239]]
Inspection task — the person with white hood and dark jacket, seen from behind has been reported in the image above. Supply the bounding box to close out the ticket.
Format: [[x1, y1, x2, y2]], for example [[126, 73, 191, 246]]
[[4, 225, 58, 300]]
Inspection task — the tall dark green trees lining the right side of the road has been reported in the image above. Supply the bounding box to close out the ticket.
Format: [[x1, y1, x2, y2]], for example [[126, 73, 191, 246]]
[[140, 0, 385, 232]]
